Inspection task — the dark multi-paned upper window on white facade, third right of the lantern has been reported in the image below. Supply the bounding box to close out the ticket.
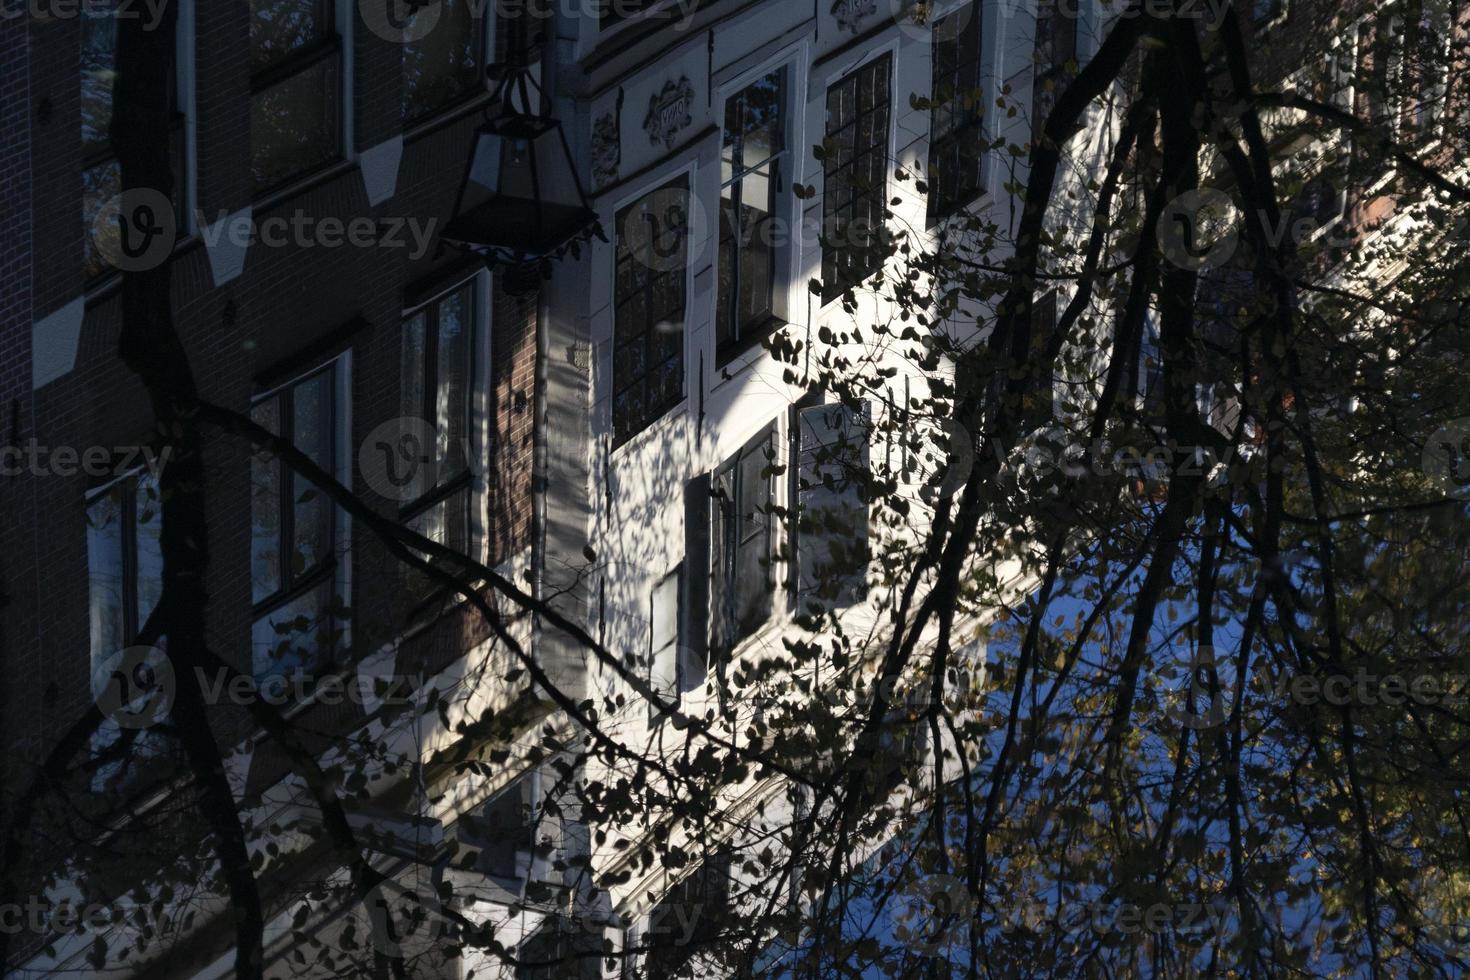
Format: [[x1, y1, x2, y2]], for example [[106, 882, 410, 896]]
[[822, 54, 892, 301]]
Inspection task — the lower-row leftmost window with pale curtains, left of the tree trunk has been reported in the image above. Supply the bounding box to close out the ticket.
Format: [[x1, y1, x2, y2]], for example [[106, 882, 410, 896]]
[[87, 470, 172, 792]]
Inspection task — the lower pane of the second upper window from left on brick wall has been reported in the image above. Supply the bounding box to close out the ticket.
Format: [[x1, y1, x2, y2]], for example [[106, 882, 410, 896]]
[[250, 53, 341, 192]]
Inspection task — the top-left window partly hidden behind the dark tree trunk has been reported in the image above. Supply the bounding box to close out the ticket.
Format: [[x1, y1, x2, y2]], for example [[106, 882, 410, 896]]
[[81, 0, 187, 279]]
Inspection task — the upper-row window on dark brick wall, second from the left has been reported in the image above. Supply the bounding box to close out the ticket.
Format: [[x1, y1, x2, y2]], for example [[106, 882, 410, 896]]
[[250, 0, 345, 194]]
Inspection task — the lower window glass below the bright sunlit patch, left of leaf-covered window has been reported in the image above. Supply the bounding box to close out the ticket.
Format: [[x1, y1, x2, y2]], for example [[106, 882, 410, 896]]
[[710, 426, 776, 657]]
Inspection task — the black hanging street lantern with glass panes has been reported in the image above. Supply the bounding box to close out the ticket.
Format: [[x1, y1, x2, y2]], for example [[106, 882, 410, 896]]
[[441, 63, 606, 276]]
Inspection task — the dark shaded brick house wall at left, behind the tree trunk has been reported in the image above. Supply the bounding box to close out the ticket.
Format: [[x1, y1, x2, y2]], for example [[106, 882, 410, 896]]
[[0, 0, 538, 975]]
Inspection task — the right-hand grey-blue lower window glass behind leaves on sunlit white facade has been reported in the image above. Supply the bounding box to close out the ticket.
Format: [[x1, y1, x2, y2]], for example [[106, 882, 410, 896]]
[[794, 404, 870, 611]]
